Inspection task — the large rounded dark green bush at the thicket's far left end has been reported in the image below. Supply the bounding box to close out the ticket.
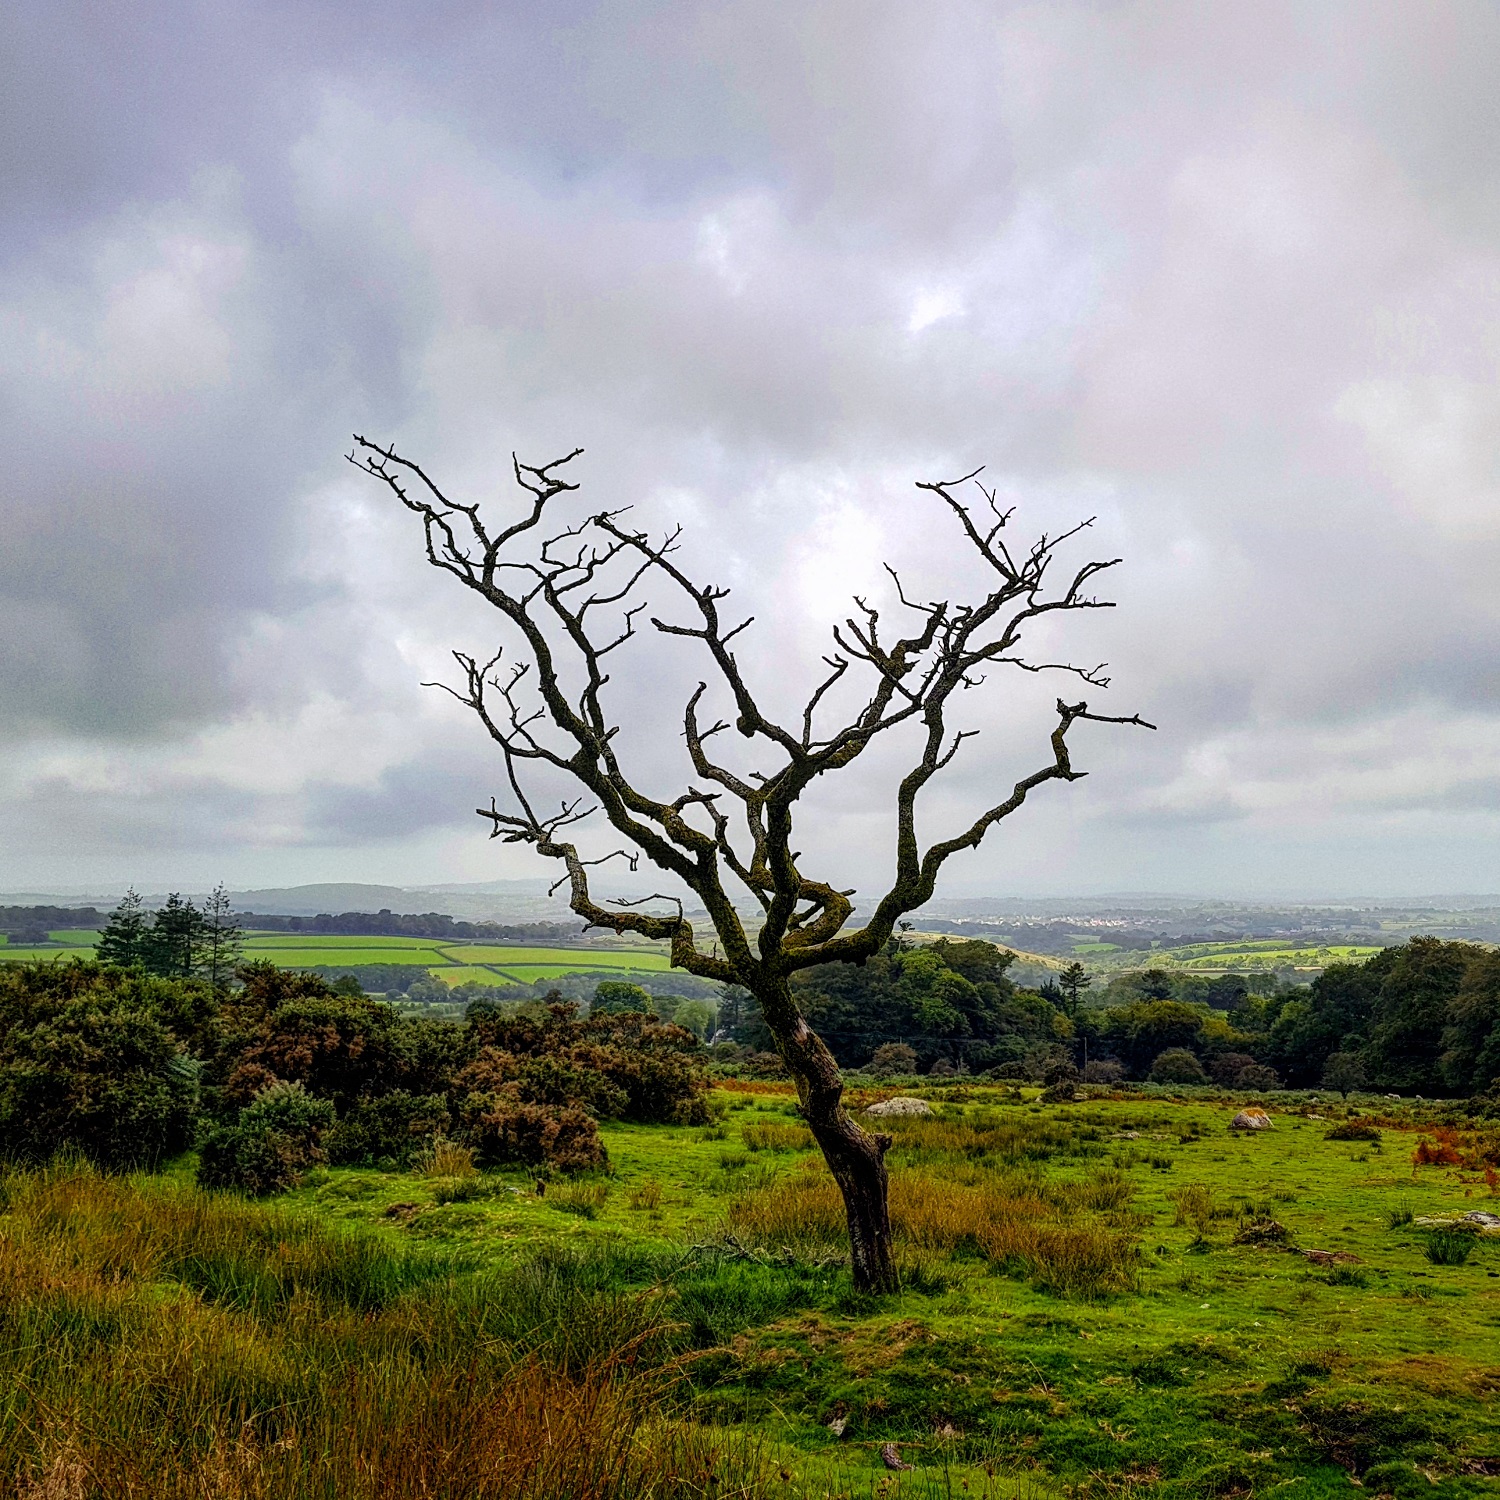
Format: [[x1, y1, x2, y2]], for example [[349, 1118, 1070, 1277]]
[[0, 965, 198, 1169]]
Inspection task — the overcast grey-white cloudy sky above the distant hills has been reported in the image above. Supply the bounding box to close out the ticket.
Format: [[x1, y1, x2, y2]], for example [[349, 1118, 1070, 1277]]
[[0, 0, 1500, 896]]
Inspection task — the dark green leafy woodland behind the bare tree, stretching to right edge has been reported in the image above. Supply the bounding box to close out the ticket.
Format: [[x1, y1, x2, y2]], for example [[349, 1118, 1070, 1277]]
[[719, 938, 1500, 1097]]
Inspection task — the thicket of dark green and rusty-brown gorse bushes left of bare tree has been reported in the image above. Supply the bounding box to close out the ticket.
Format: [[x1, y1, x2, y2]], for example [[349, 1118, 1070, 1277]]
[[0, 962, 710, 1194]]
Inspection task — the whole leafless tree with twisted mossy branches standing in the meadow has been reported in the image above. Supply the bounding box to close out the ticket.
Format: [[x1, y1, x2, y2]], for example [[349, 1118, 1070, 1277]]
[[348, 437, 1154, 1290]]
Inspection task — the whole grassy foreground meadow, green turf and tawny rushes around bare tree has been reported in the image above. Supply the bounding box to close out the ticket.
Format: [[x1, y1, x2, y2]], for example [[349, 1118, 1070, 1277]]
[[0, 1083, 1500, 1500]]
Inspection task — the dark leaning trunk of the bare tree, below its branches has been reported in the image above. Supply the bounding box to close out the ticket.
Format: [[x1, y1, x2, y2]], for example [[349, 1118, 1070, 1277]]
[[758, 984, 899, 1293]]
